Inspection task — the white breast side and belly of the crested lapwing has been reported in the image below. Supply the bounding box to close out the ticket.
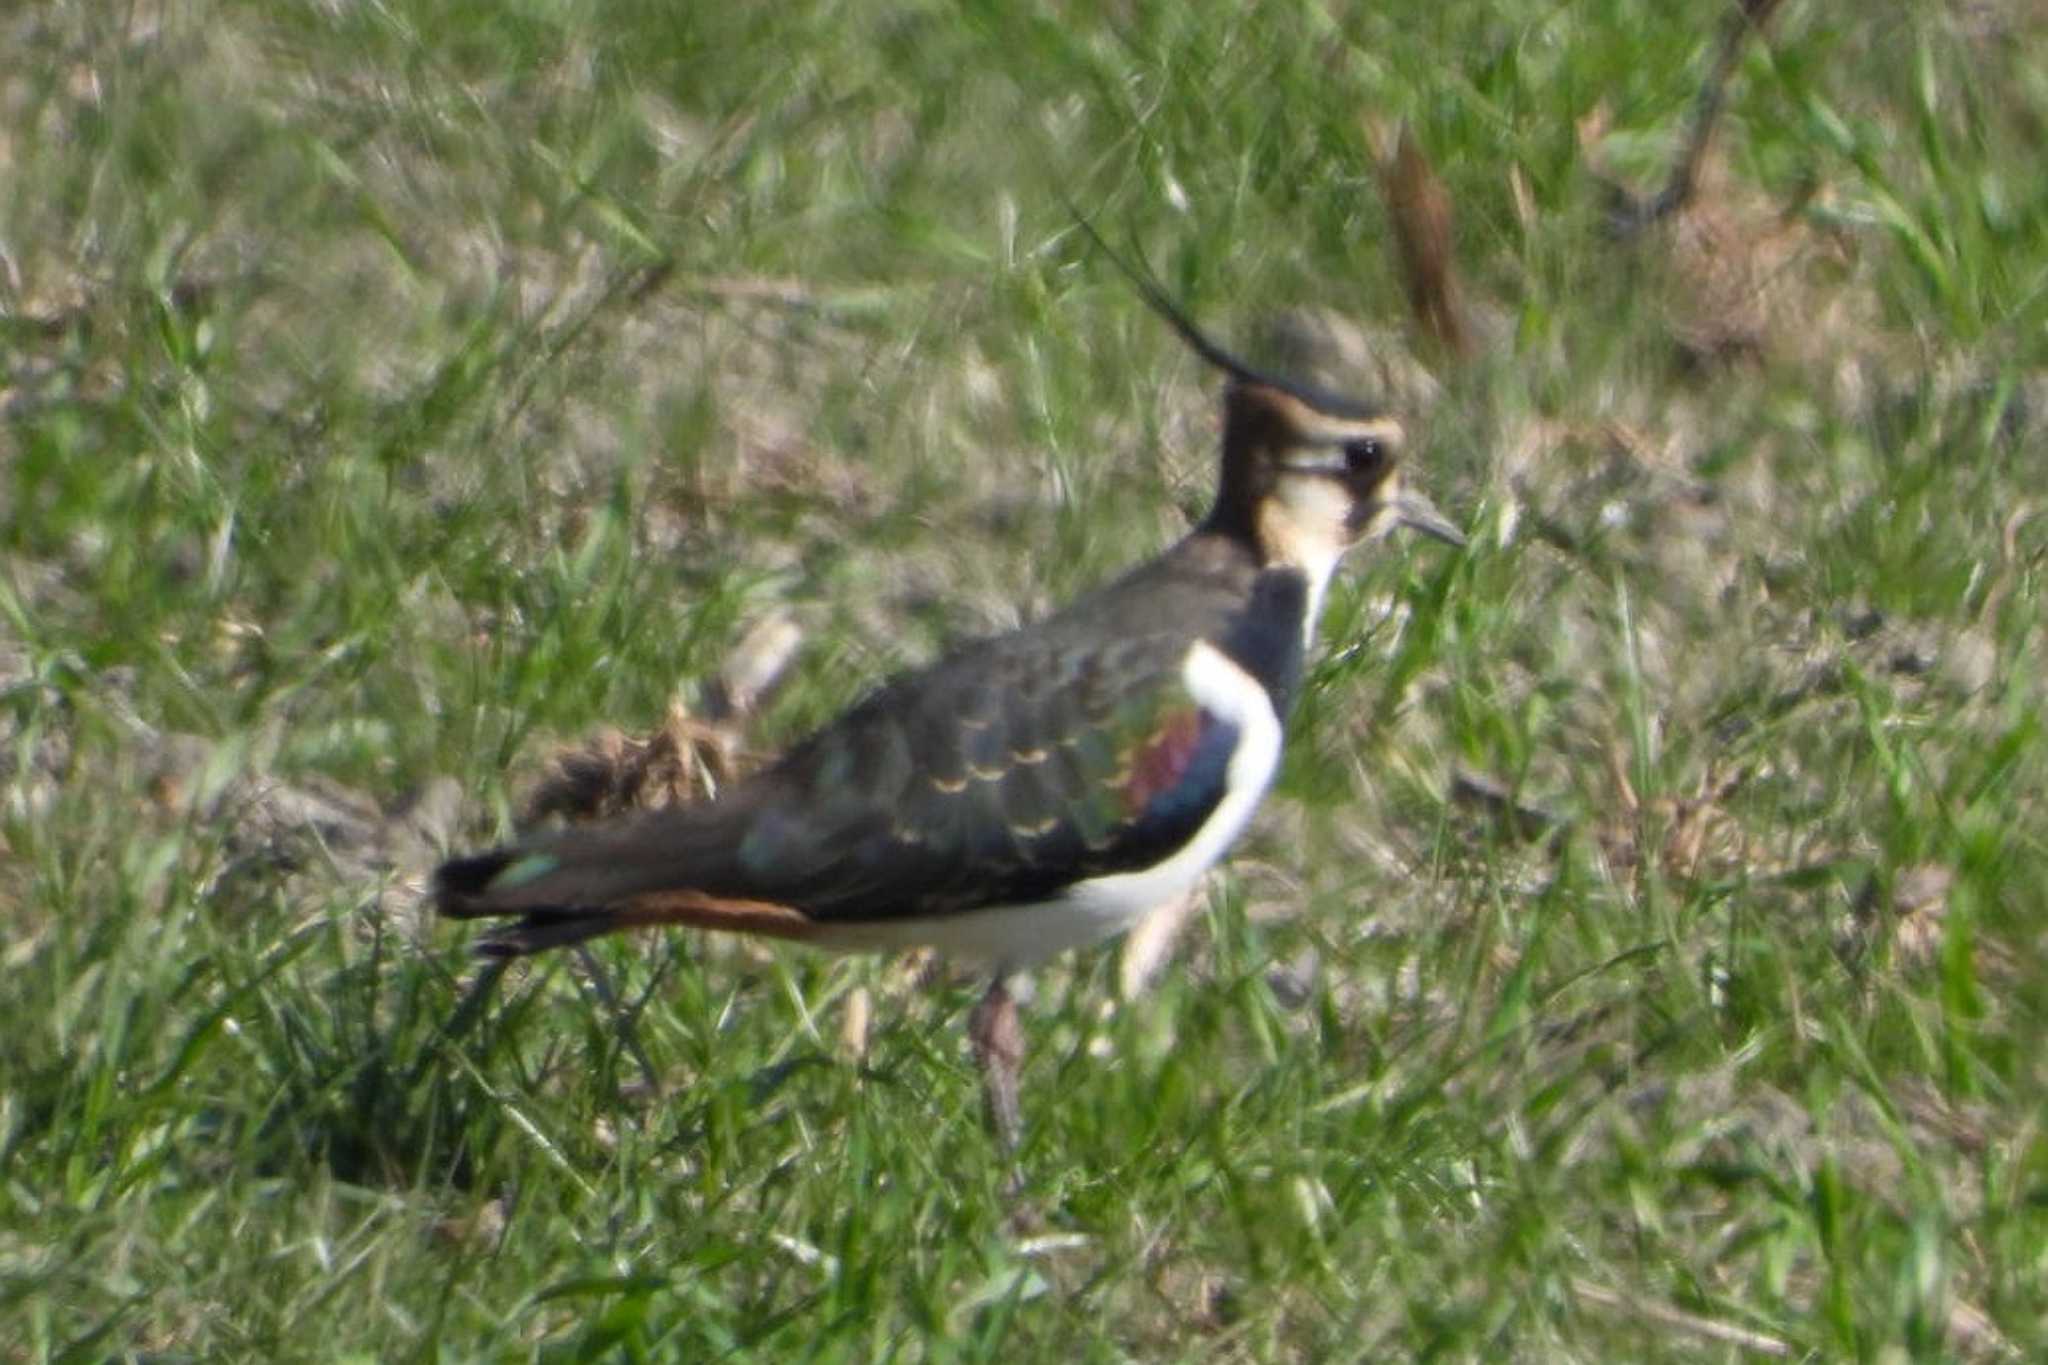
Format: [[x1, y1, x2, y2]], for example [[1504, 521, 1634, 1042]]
[[823, 642, 1277, 974]]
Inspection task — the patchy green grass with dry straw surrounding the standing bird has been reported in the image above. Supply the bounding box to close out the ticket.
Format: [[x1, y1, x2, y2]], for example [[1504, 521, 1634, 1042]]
[[0, 0, 2048, 1361]]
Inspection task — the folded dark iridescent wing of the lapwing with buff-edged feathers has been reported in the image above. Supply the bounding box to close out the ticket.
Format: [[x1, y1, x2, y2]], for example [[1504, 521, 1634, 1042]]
[[735, 636, 1237, 919]]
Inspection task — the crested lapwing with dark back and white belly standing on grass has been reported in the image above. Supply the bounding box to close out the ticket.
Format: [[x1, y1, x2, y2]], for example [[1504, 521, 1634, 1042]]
[[430, 235, 1464, 1152]]
